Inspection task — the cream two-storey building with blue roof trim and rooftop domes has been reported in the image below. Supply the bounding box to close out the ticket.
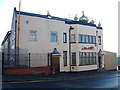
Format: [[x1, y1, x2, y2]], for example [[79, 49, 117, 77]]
[[1, 8, 104, 72]]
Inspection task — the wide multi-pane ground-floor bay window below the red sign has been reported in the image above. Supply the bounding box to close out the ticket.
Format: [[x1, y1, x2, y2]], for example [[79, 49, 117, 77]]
[[79, 52, 96, 65]]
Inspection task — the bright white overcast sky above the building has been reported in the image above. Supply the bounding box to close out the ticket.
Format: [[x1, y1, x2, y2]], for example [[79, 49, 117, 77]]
[[0, 0, 119, 53]]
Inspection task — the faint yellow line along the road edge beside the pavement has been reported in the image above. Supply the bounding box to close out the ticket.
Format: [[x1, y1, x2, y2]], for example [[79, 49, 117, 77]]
[[3, 75, 95, 84]]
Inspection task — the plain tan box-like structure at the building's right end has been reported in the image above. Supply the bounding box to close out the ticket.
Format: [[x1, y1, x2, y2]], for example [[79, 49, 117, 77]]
[[104, 51, 117, 70]]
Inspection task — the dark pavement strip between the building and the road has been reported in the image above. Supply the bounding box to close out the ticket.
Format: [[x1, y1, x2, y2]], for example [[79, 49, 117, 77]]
[[2, 70, 118, 83]]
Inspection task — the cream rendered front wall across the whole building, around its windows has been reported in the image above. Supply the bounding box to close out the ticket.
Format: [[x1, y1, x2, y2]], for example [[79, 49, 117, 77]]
[[17, 15, 103, 71]]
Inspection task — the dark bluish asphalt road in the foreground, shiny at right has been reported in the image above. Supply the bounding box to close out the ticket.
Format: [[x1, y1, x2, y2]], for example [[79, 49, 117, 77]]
[[3, 71, 120, 88]]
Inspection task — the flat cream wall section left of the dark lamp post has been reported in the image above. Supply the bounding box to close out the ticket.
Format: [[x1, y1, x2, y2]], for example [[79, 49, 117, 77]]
[[20, 15, 69, 67]]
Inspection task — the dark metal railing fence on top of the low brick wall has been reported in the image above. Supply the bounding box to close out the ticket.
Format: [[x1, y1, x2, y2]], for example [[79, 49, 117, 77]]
[[2, 53, 48, 68]]
